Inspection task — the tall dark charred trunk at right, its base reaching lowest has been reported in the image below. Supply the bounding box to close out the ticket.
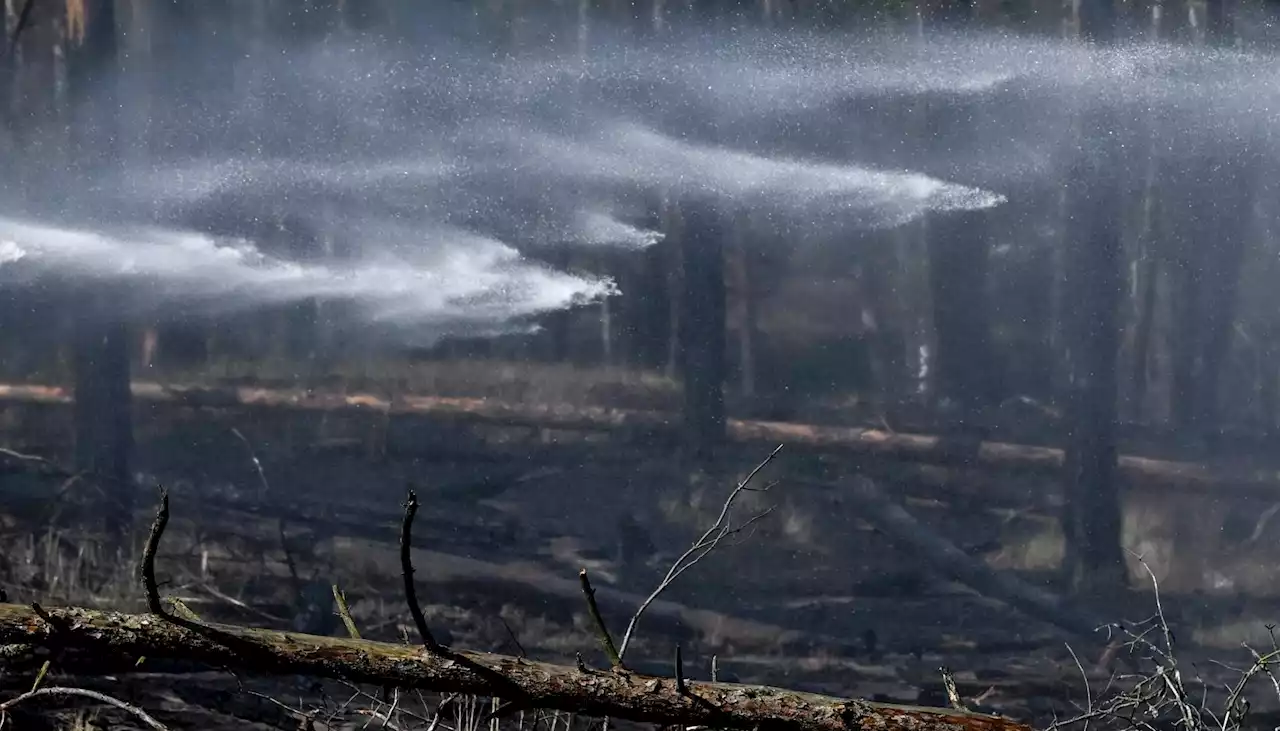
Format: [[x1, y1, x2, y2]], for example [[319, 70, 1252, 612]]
[[1062, 0, 1126, 594]]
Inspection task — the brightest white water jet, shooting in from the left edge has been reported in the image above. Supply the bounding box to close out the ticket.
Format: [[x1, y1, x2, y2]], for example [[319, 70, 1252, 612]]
[[0, 218, 614, 329]]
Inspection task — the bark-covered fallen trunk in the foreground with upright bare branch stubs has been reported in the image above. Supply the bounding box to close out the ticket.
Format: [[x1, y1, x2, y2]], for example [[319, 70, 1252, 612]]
[[0, 604, 1029, 731]]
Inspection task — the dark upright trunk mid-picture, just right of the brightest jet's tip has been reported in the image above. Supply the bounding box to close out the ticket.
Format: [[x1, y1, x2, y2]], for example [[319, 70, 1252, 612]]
[[680, 200, 728, 458]]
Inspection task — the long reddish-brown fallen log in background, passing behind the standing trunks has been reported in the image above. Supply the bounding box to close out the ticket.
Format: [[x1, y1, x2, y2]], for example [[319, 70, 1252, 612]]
[[0, 382, 1259, 497]]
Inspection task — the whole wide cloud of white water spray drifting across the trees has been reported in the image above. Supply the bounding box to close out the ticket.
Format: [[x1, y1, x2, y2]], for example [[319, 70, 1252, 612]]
[[0, 19, 1280, 340]]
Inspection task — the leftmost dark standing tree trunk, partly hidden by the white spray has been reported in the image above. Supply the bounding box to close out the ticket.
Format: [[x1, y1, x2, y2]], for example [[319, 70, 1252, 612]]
[[68, 0, 133, 538]]
